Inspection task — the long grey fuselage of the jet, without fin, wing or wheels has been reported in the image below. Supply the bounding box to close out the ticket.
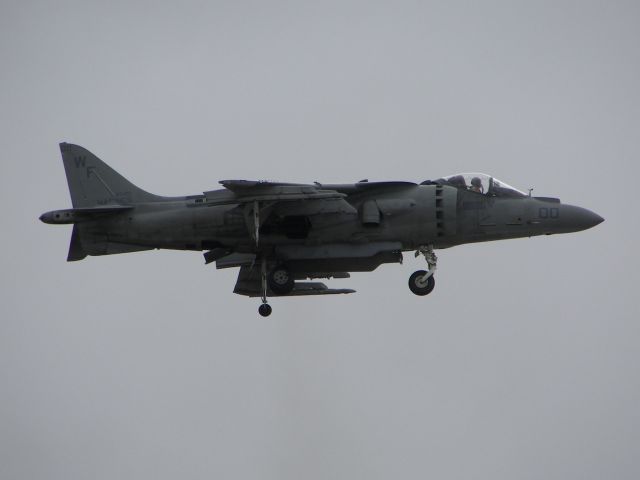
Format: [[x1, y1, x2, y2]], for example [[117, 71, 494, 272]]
[[43, 184, 601, 255]]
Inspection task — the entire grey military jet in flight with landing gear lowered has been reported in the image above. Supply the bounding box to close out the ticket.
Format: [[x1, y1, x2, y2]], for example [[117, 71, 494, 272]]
[[40, 143, 603, 317]]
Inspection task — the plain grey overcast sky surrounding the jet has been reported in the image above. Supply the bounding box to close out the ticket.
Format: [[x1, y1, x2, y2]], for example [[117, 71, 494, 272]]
[[0, 0, 640, 480]]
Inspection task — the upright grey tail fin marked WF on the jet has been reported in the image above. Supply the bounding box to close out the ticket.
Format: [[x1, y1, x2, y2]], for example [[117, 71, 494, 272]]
[[60, 143, 164, 208]]
